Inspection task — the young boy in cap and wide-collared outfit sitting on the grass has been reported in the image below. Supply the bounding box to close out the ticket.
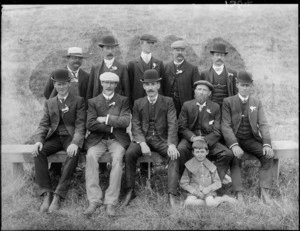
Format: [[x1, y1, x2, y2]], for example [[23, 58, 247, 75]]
[[180, 140, 237, 207]]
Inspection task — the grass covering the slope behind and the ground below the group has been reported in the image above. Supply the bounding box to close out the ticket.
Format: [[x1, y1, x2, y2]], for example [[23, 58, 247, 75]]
[[1, 4, 299, 230]]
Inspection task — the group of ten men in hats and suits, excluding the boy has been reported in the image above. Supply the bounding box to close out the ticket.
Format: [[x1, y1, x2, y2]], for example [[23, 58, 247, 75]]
[[33, 34, 273, 215]]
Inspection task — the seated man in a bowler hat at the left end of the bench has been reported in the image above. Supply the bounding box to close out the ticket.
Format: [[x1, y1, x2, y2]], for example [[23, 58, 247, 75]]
[[32, 69, 86, 213]]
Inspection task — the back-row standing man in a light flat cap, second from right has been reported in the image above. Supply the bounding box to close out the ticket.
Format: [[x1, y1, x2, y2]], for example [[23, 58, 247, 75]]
[[163, 40, 200, 117]]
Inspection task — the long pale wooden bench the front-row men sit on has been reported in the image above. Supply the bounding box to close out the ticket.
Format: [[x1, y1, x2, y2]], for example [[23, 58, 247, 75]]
[[1, 141, 299, 184]]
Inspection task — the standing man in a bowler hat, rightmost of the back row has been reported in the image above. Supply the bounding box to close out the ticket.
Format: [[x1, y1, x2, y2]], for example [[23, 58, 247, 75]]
[[200, 43, 238, 107]]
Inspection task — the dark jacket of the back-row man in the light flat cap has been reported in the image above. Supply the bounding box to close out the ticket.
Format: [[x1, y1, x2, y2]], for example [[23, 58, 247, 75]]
[[163, 60, 200, 105]]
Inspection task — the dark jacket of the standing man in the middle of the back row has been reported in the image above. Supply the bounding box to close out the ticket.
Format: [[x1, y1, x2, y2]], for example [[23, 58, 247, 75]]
[[127, 57, 164, 105]]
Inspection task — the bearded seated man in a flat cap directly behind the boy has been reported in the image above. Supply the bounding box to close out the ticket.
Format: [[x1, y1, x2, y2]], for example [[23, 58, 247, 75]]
[[172, 80, 233, 202]]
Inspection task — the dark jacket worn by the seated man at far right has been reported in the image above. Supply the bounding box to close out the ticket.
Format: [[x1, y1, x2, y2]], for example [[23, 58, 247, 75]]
[[221, 94, 271, 147]]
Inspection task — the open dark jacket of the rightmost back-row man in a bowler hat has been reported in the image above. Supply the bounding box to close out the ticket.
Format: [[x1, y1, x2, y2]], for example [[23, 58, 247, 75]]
[[200, 66, 238, 99]]
